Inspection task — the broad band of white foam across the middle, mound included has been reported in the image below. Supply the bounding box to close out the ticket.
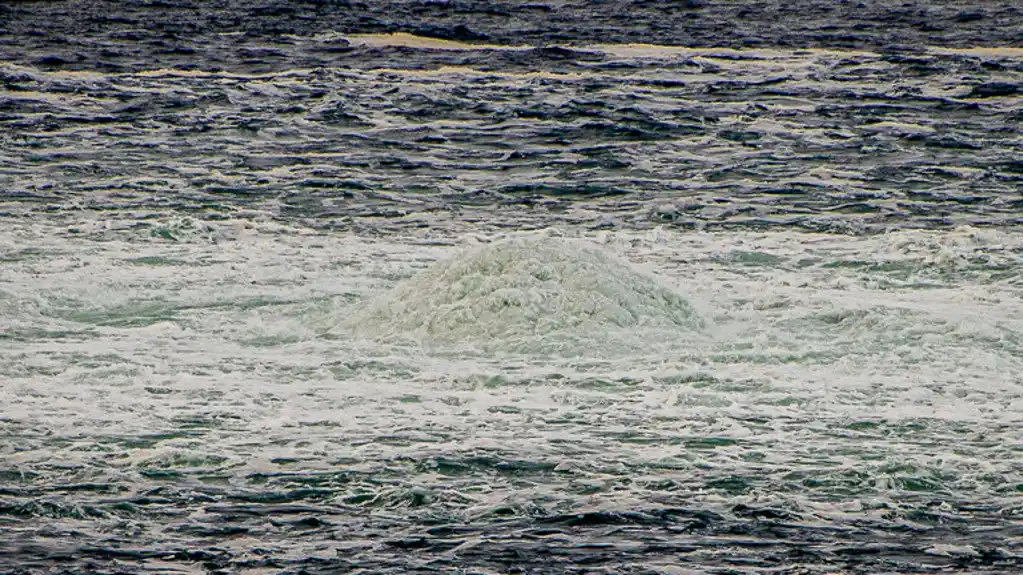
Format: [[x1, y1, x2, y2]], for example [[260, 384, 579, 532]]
[[0, 220, 1023, 519]]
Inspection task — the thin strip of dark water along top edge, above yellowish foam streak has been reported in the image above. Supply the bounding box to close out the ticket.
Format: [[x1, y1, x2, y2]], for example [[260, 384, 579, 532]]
[[6, 0, 1023, 72]]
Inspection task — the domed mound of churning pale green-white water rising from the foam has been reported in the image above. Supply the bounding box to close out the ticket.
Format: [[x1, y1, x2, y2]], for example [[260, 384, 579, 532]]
[[350, 235, 704, 355]]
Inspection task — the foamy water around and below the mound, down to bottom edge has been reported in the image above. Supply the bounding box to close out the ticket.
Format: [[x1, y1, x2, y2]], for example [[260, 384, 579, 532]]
[[0, 217, 1023, 572]]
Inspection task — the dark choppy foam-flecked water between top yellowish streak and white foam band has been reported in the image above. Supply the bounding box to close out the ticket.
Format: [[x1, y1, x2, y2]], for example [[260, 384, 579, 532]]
[[0, 37, 1023, 233]]
